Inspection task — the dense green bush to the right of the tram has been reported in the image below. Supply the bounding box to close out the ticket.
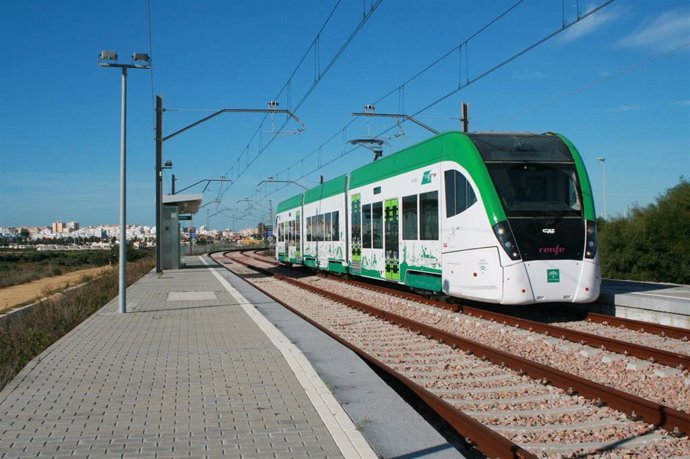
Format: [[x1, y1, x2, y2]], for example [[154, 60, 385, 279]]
[[599, 177, 690, 284]]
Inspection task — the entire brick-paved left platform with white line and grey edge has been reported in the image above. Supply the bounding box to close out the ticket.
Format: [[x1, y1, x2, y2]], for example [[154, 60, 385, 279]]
[[0, 257, 462, 458]]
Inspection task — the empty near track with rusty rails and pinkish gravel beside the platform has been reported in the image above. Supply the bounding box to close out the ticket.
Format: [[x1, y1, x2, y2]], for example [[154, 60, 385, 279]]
[[212, 255, 690, 457]]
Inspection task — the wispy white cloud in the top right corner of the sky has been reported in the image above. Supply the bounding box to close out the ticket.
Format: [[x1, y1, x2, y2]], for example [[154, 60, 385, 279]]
[[618, 8, 690, 51]]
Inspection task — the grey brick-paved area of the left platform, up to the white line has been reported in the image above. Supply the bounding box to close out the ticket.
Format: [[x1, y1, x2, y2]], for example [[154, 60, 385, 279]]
[[0, 258, 373, 458]]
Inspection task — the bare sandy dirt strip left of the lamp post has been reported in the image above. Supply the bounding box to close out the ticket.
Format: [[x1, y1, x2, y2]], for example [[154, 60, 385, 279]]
[[0, 266, 111, 312]]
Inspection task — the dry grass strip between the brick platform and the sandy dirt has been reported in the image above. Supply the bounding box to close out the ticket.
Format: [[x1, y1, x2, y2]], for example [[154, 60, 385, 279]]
[[0, 257, 155, 389]]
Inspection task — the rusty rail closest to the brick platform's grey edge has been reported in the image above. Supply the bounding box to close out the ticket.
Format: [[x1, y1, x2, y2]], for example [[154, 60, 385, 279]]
[[214, 253, 537, 459]]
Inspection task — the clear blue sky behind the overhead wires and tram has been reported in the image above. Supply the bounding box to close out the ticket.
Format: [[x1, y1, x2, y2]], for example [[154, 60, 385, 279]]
[[0, 0, 690, 229]]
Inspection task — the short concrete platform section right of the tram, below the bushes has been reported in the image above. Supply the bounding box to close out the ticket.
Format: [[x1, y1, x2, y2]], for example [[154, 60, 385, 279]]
[[593, 279, 690, 328]]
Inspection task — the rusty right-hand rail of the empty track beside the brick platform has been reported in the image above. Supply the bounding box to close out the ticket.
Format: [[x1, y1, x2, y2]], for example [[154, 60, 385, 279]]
[[222, 253, 690, 434]]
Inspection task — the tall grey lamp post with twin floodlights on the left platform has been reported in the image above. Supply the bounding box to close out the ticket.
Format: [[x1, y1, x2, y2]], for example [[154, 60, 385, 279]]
[[98, 51, 151, 314]]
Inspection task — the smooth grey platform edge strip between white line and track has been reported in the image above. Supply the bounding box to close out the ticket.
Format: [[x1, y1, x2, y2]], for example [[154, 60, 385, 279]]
[[218, 258, 463, 459]]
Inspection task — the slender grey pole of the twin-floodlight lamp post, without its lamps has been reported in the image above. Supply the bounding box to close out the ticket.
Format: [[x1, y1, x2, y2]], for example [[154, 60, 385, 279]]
[[119, 67, 127, 314]]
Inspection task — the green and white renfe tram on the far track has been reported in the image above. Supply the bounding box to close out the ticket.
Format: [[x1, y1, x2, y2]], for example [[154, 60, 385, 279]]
[[276, 132, 601, 304]]
